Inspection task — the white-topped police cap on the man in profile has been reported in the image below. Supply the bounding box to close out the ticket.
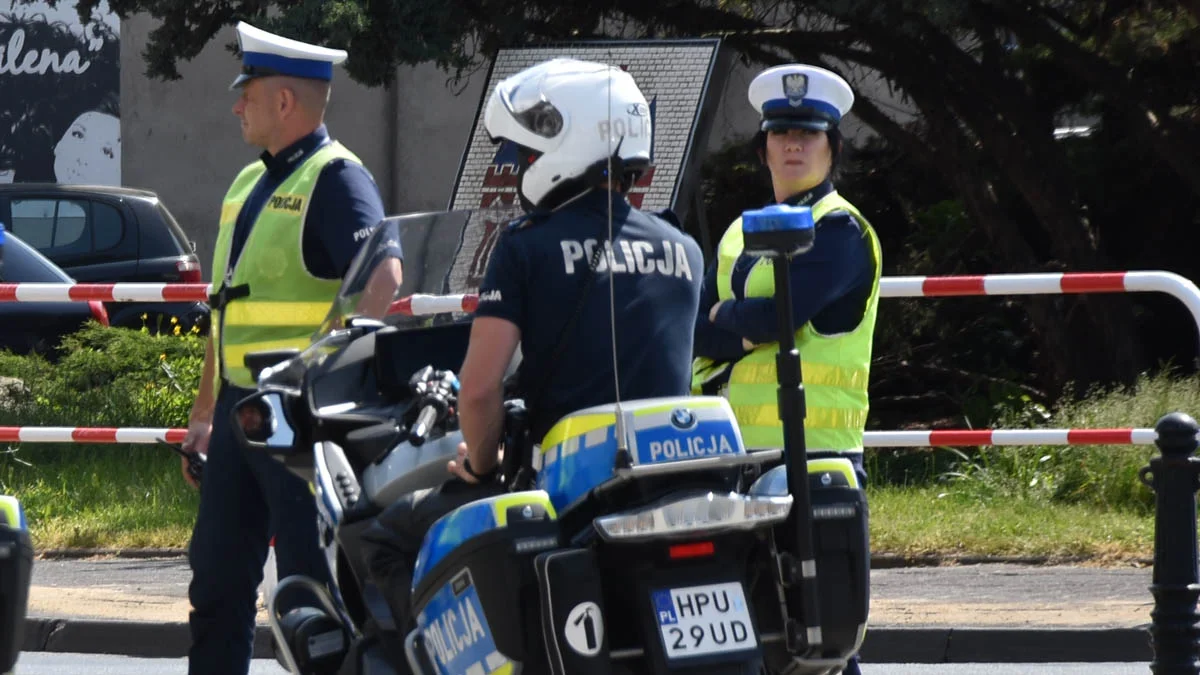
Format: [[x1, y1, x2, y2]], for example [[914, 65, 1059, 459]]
[[229, 22, 347, 89]]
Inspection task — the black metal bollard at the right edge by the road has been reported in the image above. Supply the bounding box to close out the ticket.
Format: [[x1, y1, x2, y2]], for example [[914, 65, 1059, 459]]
[[1139, 412, 1200, 675]]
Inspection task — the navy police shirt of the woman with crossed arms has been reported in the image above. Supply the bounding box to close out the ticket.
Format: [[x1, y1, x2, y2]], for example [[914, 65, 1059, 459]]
[[695, 180, 878, 362]]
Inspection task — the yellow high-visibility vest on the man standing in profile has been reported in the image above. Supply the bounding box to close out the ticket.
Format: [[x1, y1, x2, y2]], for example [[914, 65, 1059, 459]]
[[210, 141, 361, 387]]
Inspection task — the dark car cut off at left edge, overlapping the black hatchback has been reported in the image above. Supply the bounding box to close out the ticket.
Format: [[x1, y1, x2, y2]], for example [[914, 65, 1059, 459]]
[[0, 227, 109, 356]]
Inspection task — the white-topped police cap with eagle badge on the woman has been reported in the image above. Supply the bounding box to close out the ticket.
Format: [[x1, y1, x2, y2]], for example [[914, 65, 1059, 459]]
[[748, 64, 854, 131]]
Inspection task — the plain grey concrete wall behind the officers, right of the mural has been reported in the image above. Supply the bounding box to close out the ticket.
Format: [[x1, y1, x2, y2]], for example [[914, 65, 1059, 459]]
[[121, 16, 907, 279]]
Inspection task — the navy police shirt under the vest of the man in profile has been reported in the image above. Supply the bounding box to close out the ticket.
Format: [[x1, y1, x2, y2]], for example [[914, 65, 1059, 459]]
[[226, 125, 384, 279]]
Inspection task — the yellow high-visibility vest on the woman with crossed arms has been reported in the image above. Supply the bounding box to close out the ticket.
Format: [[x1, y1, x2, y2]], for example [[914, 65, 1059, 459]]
[[692, 192, 882, 452]]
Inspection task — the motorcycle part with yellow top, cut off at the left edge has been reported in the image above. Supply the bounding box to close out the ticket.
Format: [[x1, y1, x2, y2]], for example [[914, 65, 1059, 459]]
[[0, 495, 34, 673]]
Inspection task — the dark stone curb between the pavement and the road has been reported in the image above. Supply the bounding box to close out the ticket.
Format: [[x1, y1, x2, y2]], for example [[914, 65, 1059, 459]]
[[22, 619, 1154, 663]]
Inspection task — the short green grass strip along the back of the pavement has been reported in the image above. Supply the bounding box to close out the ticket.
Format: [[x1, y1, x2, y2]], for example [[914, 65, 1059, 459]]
[[5, 475, 1154, 562]]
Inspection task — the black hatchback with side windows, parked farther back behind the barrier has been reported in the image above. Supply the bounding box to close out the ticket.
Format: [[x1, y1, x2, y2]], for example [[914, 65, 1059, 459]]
[[0, 183, 209, 331]]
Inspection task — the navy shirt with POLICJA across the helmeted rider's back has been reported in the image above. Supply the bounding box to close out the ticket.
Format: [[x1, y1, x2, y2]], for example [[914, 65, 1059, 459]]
[[475, 191, 703, 442]]
